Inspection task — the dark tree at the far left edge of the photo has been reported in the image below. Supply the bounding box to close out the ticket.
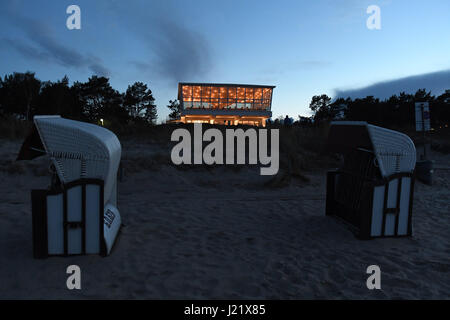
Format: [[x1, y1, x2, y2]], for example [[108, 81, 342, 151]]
[[0, 72, 41, 120]]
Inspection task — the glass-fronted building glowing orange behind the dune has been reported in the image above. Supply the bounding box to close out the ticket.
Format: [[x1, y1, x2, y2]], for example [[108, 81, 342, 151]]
[[177, 83, 275, 126]]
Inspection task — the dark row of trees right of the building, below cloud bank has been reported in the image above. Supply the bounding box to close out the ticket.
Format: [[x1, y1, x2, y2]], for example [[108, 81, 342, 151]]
[[308, 89, 450, 127]]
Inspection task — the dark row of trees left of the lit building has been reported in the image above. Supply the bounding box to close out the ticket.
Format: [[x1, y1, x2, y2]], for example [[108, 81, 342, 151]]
[[0, 72, 157, 125]]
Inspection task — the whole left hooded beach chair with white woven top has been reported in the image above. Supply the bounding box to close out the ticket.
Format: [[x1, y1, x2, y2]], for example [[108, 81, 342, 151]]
[[18, 116, 121, 258]]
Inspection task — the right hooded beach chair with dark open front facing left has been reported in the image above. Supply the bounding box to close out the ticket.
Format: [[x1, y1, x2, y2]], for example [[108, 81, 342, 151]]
[[326, 121, 416, 239]]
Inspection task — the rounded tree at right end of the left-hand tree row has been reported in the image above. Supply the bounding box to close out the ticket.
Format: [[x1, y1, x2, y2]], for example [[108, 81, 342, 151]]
[[124, 82, 157, 124]]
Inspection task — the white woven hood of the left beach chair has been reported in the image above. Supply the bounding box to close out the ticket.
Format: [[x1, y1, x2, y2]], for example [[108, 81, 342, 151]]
[[18, 116, 121, 204]]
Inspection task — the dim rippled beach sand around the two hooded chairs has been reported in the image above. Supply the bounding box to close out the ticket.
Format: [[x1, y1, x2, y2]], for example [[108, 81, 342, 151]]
[[0, 140, 450, 299]]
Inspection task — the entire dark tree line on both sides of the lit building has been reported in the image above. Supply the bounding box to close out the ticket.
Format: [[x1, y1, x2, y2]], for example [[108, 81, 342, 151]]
[[0, 72, 450, 127]]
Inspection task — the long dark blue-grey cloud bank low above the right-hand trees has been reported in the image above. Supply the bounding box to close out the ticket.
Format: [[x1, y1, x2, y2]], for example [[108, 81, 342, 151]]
[[335, 70, 450, 99]]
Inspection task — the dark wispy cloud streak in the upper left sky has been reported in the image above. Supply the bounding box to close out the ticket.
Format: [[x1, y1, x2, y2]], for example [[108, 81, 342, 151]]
[[3, 8, 110, 76]]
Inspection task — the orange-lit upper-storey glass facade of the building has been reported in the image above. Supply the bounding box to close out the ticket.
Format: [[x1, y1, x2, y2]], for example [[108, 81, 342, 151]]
[[179, 84, 273, 111]]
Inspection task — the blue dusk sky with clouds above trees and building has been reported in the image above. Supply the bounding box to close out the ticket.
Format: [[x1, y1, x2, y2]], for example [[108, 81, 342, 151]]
[[0, 0, 450, 120]]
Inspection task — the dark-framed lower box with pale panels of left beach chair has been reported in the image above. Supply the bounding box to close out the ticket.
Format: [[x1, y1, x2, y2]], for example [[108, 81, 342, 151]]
[[31, 179, 106, 259]]
